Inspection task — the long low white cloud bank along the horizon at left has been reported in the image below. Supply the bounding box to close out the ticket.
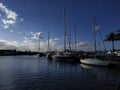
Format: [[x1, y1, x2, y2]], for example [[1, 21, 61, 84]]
[[0, 37, 61, 51]]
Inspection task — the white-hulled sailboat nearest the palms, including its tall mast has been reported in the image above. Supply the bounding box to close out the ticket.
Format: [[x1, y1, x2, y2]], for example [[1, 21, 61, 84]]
[[80, 16, 110, 66]]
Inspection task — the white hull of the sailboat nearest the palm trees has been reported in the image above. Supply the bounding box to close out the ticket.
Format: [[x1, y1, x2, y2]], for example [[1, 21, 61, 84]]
[[80, 59, 110, 66]]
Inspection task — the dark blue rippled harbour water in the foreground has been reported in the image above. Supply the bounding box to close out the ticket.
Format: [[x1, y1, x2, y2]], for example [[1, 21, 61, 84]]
[[0, 56, 120, 90]]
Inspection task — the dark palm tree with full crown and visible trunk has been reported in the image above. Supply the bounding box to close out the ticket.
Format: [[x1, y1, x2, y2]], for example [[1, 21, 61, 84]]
[[105, 32, 117, 52]]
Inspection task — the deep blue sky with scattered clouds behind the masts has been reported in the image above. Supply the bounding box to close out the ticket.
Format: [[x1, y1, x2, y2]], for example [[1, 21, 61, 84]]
[[0, 0, 120, 51]]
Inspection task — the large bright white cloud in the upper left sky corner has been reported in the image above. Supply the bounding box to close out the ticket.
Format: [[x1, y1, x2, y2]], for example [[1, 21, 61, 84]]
[[0, 3, 18, 29]]
